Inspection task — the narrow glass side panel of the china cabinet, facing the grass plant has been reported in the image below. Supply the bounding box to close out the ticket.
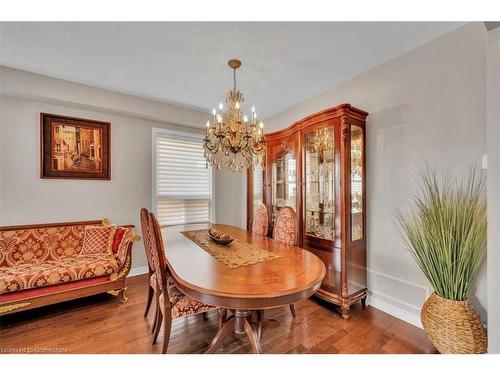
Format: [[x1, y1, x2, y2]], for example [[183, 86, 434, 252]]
[[351, 125, 364, 241]]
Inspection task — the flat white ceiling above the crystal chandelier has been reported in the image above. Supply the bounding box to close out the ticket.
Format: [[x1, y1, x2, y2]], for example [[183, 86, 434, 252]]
[[0, 22, 462, 118]]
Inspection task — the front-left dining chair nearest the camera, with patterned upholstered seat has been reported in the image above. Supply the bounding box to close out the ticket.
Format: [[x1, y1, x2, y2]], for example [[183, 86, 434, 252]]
[[149, 213, 219, 354]]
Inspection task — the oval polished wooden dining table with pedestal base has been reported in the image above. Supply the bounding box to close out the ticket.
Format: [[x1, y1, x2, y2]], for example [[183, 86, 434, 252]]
[[163, 225, 326, 353]]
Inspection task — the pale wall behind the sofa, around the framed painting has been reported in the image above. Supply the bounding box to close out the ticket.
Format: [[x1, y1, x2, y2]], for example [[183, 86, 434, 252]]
[[0, 67, 206, 268]]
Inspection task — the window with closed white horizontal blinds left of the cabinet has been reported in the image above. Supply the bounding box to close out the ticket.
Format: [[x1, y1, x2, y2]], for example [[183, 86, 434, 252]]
[[153, 129, 212, 226]]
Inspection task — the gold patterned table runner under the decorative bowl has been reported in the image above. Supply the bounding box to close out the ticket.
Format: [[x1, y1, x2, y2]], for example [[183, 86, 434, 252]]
[[182, 229, 281, 269]]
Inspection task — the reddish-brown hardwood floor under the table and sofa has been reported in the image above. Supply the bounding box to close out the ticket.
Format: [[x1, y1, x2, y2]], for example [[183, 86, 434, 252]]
[[0, 275, 434, 353]]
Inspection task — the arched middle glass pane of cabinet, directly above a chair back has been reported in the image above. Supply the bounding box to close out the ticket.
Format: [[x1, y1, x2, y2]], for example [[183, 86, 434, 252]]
[[271, 151, 297, 223]]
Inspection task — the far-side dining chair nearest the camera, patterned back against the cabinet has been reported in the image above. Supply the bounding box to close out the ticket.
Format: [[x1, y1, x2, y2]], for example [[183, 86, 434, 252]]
[[257, 206, 297, 338]]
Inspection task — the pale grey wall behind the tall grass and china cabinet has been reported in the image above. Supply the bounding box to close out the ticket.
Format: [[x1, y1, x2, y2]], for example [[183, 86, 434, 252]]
[[265, 23, 487, 325]]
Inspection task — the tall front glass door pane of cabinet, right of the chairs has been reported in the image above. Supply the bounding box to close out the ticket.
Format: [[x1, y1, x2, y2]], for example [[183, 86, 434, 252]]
[[304, 127, 335, 240]]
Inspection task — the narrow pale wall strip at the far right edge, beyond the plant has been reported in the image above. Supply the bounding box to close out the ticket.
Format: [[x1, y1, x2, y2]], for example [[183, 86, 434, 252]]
[[487, 27, 500, 353]]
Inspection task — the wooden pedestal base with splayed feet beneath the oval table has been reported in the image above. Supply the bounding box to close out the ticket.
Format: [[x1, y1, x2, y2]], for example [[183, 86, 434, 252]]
[[205, 310, 262, 354]]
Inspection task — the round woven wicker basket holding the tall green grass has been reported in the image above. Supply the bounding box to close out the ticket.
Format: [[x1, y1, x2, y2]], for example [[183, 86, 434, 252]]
[[420, 293, 488, 354]]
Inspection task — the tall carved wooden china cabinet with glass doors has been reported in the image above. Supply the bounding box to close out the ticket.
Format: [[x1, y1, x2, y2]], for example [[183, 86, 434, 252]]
[[247, 104, 368, 318]]
